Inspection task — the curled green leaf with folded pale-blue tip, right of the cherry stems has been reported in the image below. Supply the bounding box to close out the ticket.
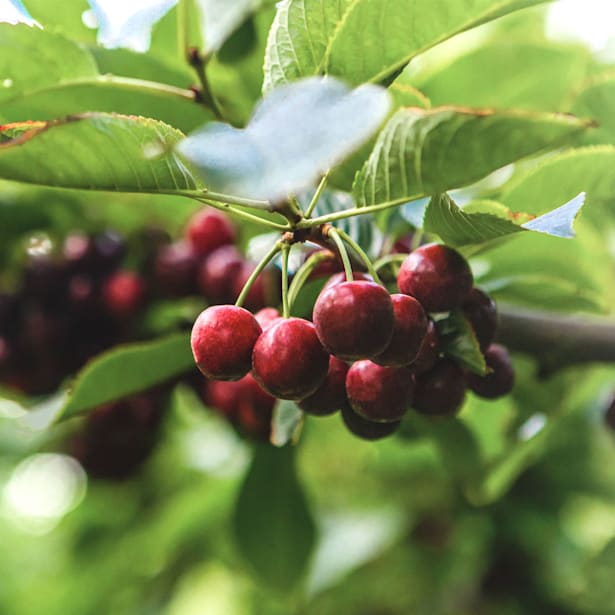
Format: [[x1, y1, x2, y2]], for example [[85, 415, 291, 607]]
[[423, 193, 585, 246]]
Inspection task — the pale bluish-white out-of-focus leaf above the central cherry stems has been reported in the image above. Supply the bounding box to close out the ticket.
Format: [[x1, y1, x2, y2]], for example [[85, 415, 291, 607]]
[[177, 78, 390, 201]]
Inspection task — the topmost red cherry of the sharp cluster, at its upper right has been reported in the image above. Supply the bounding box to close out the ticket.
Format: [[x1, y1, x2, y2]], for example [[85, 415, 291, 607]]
[[397, 243, 473, 312]]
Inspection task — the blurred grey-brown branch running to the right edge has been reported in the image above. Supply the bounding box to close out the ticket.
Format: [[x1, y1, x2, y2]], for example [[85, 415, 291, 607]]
[[497, 305, 615, 374]]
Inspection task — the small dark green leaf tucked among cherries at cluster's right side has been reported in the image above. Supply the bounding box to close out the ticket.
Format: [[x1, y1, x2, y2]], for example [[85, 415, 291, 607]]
[[437, 310, 487, 376]]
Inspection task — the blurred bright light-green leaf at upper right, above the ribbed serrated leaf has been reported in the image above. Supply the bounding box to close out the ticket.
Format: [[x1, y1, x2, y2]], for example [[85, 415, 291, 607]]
[[412, 37, 592, 111]]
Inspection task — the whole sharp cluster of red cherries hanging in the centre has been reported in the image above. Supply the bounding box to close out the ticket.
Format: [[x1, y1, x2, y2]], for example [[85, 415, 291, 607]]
[[191, 244, 514, 439]]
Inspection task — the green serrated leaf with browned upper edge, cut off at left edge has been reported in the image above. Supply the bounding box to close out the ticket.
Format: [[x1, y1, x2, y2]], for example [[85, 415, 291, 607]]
[[0, 113, 199, 192]]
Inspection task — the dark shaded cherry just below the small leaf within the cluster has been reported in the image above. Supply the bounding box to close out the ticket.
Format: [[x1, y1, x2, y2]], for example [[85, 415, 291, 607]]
[[412, 359, 466, 416]]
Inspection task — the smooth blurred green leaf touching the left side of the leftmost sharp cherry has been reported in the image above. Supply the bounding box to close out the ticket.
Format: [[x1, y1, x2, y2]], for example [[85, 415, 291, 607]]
[[59, 333, 194, 418]]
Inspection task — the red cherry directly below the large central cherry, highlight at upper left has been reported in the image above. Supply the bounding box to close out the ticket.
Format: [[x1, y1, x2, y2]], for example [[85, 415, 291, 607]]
[[346, 361, 414, 423]]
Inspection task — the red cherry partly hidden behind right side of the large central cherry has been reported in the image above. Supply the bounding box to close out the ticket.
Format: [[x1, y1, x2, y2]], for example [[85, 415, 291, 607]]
[[373, 294, 429, 367]]
